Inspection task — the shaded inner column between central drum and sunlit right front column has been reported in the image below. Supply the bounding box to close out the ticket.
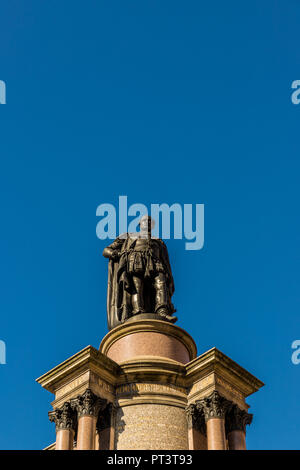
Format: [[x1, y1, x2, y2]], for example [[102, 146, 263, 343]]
[[185, 404, 207, 450]]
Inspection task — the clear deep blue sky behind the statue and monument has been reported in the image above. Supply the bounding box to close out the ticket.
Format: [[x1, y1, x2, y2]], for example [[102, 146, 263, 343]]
[[0, 0, 300, 449]]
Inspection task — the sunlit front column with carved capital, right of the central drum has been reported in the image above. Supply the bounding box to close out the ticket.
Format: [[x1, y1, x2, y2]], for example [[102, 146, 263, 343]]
[[196, 390, 231, 450]]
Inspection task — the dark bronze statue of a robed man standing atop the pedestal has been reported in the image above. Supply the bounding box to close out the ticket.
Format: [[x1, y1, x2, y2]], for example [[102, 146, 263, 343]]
[[103, 216, 177, 330]]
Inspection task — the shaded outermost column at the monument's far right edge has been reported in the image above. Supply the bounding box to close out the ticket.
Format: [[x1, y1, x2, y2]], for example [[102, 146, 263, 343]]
[[226, 405, 253, 450]]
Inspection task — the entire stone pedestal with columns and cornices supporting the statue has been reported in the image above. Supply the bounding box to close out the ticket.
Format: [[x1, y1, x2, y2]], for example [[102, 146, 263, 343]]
[[38, 315, 263, 451]]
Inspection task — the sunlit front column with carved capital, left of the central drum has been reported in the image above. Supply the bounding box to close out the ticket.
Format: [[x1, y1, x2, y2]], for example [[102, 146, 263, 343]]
[[71, 388, 106, 450]]
